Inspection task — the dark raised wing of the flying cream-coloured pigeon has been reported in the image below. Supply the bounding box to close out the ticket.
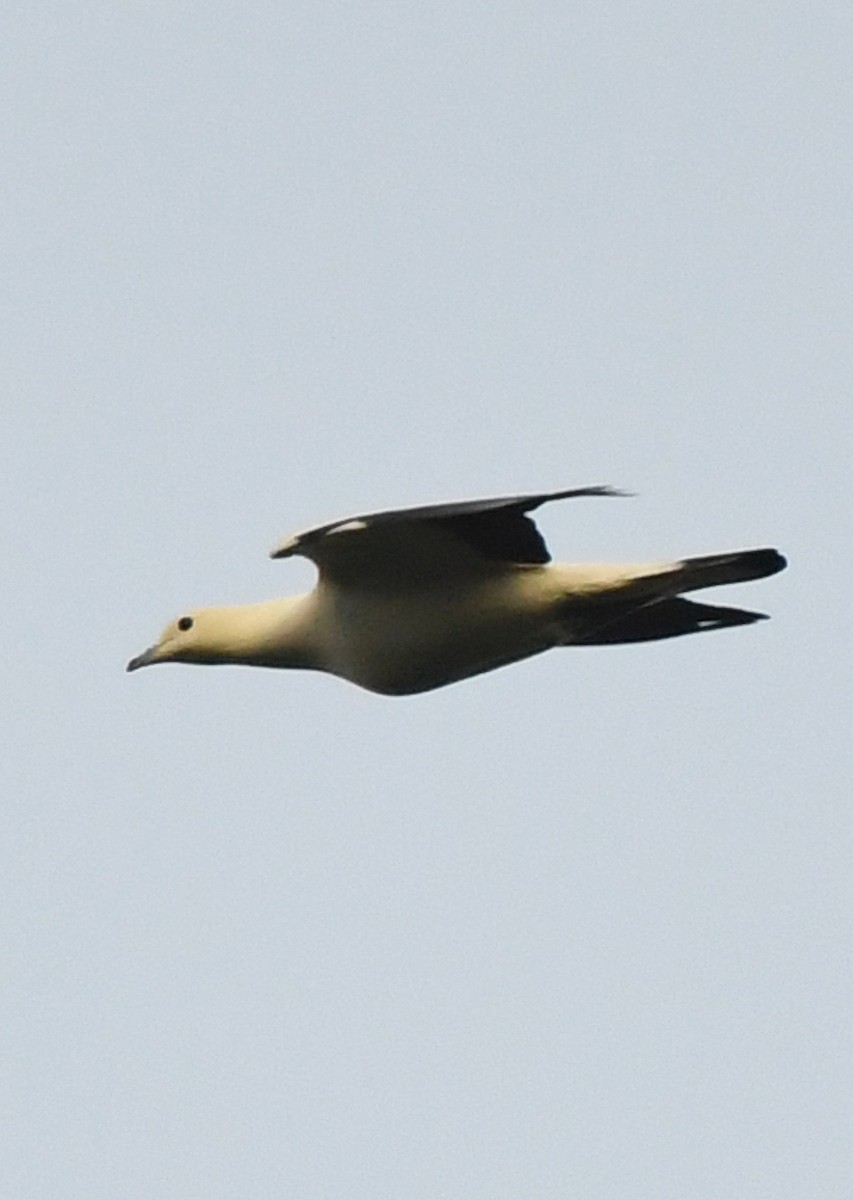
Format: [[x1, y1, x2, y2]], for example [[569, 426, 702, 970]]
[[271, 487, 626, 583]]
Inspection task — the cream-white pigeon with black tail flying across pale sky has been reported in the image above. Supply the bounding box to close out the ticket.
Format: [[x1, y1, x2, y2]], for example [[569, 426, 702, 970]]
[[127, 486, 787, 696]]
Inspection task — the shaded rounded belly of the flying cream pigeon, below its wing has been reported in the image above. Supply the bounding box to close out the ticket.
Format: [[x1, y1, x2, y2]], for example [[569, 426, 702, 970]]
[[316, 580, 554, 696]]
